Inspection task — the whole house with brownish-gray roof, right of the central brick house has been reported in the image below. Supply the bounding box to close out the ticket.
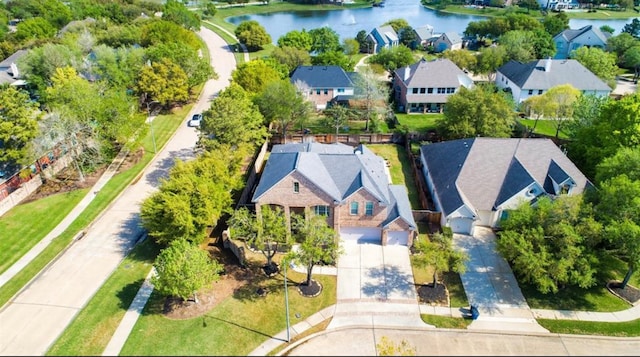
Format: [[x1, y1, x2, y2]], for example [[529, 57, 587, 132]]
[[420, 138, 593, 234]]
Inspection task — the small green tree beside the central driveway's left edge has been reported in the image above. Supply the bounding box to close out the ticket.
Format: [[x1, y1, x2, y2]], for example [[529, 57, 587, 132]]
[[287, 213, 342, 286]]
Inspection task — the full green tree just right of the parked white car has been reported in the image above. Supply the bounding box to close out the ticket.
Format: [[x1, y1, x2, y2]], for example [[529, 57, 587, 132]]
[[200, 83, 267, 150]]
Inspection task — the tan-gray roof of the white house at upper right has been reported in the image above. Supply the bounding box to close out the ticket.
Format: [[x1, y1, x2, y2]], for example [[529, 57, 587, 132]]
[[498, 59, 611, 91]]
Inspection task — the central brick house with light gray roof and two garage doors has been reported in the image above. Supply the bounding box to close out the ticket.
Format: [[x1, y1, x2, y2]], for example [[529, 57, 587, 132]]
[[252, 143, 417, 246]]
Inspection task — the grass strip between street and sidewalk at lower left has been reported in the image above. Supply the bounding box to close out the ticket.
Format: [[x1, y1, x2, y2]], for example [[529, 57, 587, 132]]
[[47, 239, 160, 356]]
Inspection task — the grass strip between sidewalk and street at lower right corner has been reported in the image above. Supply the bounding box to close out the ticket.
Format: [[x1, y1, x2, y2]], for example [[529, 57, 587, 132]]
[[536, 319, 640, 337]]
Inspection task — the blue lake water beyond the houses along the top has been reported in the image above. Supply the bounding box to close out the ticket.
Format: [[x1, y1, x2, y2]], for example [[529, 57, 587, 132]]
[[226, 0, 632, 43]]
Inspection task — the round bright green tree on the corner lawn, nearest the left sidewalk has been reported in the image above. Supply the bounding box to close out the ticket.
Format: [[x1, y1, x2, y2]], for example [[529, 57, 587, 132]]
[[151, 239, 223, 304]]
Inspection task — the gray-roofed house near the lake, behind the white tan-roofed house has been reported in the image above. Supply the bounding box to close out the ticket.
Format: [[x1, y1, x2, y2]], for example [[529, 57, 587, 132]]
[[553, 25, 611, 59]]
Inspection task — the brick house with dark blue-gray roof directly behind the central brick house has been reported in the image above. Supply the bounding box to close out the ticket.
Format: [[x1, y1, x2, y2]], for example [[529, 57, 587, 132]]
[[290, 66, 355, 110]]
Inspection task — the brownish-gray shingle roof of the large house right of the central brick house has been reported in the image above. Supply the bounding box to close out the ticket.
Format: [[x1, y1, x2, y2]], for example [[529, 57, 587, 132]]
[[420, 138, 591, 215]]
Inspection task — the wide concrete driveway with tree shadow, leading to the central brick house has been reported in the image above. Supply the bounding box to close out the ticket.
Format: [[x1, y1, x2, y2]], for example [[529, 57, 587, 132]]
[[328, 240, 429, 329]]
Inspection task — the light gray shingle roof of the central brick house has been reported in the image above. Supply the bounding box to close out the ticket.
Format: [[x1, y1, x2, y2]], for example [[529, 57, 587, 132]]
[[252, 143, 415, 227]]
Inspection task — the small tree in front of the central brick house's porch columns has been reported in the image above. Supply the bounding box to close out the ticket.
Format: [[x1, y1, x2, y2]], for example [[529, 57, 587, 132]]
[[228, 205, 288, 275]]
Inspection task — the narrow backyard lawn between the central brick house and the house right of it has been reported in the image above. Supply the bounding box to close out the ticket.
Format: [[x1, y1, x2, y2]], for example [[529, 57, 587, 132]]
[[367, 144, 420, 209]]
